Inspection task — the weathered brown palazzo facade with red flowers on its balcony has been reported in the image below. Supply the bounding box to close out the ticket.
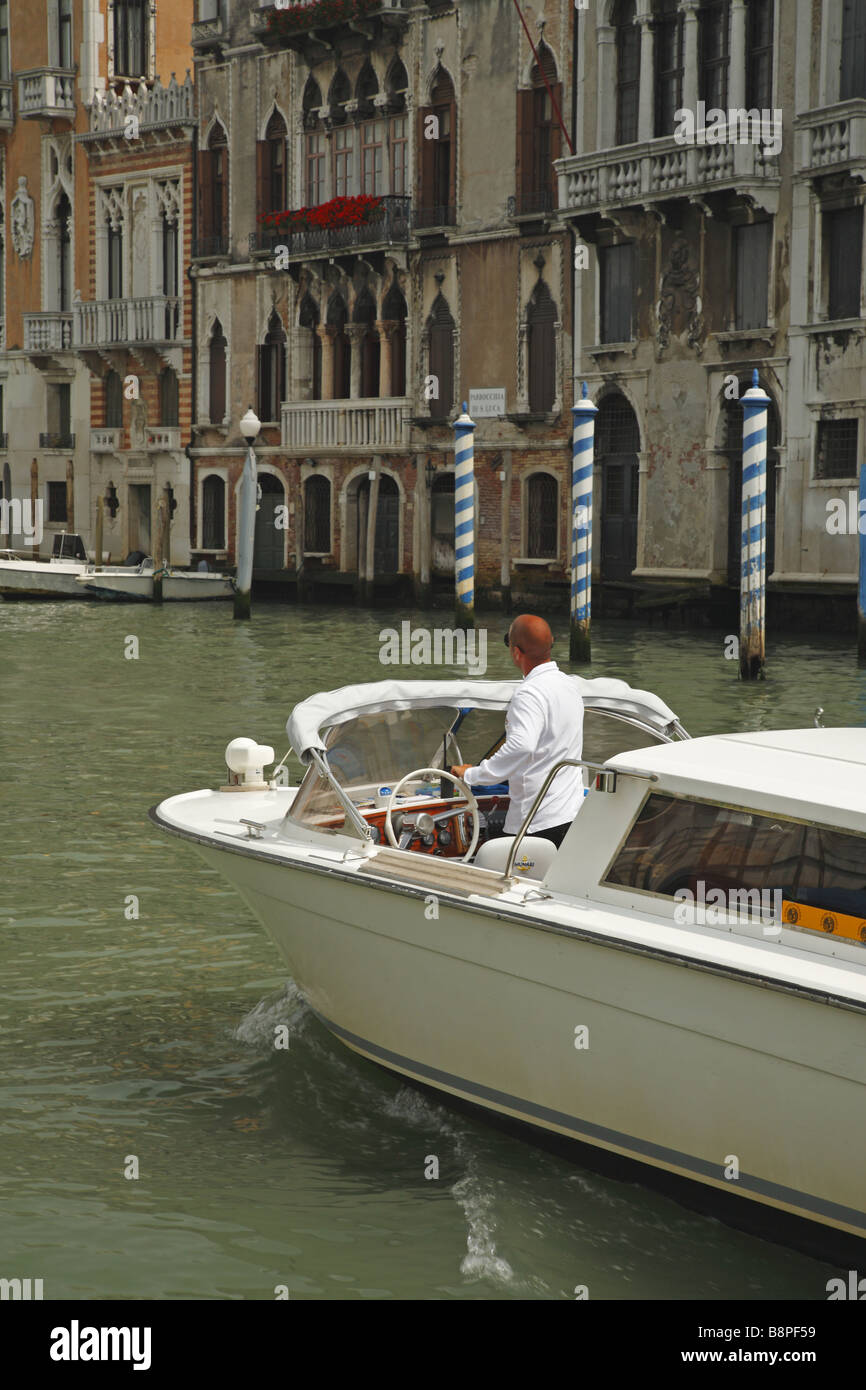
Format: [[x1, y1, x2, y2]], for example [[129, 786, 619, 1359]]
[[192, 0, 573, 598]]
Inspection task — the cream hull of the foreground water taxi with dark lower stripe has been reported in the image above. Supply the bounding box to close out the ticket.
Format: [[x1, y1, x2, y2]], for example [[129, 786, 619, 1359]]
[[197, 844, 866, 1237]]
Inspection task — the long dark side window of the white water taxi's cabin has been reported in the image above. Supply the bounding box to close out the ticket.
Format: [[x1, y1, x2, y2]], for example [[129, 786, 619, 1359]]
[[602, 792, 866, 941]]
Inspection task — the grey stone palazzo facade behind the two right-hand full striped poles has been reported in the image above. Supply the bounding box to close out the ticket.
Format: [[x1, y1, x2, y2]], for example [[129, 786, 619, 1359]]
[[557, 0, 866, 624]]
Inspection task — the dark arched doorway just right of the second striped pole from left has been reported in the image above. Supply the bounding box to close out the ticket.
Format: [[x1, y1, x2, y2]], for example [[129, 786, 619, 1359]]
[[595, 392, 641, 580]]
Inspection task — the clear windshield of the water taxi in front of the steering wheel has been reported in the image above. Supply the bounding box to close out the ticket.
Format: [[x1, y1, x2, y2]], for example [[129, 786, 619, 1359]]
[[289, 706, 505, 831]]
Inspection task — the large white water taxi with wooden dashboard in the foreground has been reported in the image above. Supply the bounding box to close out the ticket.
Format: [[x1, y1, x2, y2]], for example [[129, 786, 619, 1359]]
[[150, 677, 866, 1248]]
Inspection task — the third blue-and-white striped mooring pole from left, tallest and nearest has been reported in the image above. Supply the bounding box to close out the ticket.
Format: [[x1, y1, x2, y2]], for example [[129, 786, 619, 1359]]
[[740, 368, 770, 681]]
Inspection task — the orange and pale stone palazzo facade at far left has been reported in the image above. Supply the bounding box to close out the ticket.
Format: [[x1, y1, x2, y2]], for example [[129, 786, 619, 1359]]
[[0, 0, 193, 562]]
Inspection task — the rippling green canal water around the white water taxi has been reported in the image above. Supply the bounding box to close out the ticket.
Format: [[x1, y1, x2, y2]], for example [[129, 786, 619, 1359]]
[[0, 602, 866, 1300]]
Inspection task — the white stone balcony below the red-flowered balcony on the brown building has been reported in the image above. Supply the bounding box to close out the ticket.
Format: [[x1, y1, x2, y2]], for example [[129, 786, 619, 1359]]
[[281, 396, 410, 450]]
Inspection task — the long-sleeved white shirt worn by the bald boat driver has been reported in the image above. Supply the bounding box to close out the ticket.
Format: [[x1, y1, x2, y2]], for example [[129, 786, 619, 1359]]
[[464, 662, 584, 835]]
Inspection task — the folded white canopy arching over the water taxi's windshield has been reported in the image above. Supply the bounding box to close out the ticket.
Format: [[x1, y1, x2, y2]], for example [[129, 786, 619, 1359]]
[[286, 676, 683, 763]]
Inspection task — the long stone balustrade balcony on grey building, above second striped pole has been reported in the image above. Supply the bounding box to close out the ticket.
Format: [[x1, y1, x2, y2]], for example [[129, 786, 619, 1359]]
[[555, 135, 780, 215]]
